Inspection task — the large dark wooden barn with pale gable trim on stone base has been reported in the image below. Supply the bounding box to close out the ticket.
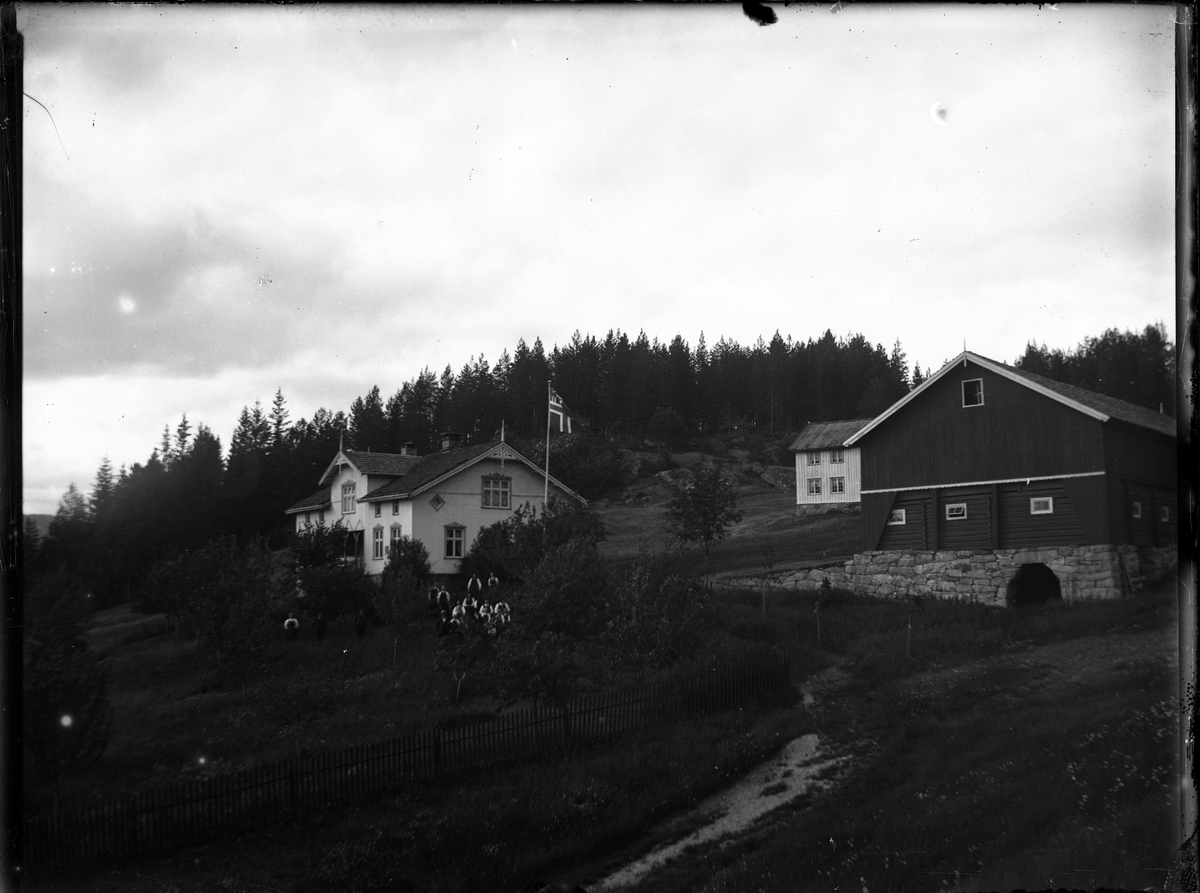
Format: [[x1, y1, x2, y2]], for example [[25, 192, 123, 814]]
[[846, 352, 1177, 603]]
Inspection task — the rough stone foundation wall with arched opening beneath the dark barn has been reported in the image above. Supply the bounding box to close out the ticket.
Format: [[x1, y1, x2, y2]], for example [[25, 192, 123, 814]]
[[728, 546, 1175, 605]]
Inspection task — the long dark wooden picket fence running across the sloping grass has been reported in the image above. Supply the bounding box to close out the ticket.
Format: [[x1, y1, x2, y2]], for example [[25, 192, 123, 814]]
[[22, 652, 791, 871]]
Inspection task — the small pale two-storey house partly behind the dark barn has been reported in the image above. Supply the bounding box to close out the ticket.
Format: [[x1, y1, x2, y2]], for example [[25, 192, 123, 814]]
[[790, 419, 872, 505]]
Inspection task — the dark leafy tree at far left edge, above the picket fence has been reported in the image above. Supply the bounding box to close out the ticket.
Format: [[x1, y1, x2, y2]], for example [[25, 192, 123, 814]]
[[23, 573, 113, 801]]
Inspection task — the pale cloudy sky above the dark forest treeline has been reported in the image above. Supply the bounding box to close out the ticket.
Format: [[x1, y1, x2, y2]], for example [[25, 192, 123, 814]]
[[18, 4, 1175, 513]]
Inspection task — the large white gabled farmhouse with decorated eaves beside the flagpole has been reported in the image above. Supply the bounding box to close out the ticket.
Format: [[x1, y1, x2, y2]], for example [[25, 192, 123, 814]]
[[287, 434, 582, 575]]
